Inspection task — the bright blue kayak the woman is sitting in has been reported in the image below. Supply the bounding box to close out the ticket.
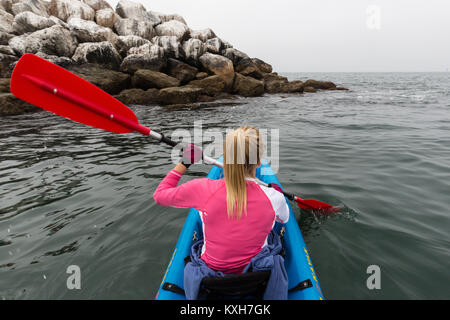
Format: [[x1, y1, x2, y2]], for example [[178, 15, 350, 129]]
[[156, 162, 324, 300]]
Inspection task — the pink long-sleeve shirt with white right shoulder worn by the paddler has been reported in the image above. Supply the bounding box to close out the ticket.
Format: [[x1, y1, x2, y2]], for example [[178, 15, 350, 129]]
[[153, 170, 289, 273]]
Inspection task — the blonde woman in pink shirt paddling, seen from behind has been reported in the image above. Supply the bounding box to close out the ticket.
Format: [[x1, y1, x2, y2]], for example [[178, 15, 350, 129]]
[[153, 126, 289, 274]]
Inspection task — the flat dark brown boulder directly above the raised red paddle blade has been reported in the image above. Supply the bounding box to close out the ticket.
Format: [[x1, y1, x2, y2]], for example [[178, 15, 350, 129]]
[[69, 64, 131, 94]]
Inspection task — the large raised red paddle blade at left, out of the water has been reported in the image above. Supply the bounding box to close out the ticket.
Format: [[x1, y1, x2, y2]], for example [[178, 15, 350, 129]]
[[11, 53, 138, 133]]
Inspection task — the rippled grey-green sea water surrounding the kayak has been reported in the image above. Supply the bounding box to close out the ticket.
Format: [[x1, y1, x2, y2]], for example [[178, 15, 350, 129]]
[[0, 73, 450, 299]]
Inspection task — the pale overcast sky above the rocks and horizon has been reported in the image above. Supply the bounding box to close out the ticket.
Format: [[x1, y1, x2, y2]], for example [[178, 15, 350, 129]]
[[108, 0, 450, 72]]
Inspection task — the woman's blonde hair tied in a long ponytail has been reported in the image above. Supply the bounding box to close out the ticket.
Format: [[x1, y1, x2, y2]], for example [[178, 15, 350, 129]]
[[224, 126, 264, 220]]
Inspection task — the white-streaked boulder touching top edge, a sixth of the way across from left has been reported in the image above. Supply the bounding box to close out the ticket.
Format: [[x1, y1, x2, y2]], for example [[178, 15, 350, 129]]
[[48, 0, 95, 22]]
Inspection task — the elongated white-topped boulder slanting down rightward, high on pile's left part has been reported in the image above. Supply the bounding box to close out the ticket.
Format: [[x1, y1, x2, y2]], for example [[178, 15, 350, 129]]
[[67, 18, 118, 45]]
